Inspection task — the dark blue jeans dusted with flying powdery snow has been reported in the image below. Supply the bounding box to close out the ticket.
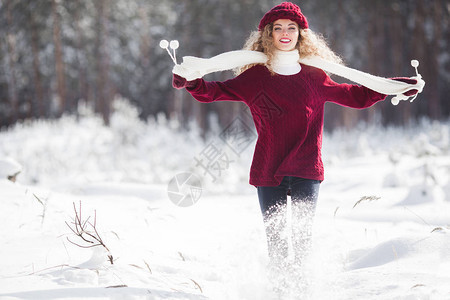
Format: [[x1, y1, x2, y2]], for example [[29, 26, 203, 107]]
[[257, 176, 320, 267]]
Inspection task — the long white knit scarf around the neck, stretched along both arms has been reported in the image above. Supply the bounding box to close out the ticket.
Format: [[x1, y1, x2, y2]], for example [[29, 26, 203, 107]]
[[173, 50, 425, 105]]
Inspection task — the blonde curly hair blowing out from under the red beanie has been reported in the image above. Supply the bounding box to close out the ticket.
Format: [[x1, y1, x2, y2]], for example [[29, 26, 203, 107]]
[[235, 23, 343, 75]]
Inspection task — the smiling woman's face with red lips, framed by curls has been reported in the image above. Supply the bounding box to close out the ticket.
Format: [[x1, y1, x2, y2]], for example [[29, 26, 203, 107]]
[[272, 19, 299, 51]]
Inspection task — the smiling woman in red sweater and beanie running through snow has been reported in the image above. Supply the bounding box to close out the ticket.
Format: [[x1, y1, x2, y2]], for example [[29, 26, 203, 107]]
[[173, 2, 417, 290]]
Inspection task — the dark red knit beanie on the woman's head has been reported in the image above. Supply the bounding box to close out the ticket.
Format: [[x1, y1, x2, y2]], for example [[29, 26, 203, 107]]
[[258, 2, 308, 31]]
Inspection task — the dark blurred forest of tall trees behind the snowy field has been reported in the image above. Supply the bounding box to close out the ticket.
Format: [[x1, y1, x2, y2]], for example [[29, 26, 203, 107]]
[[0, 0, 450, 132]]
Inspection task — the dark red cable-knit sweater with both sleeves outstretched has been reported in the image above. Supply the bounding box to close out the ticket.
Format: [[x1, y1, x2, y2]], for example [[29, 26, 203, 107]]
[[187, 65, 386, 186]]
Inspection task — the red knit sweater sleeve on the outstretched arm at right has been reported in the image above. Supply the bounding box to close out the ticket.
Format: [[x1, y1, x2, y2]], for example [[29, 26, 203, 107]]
[[318, 70, 387, 108]]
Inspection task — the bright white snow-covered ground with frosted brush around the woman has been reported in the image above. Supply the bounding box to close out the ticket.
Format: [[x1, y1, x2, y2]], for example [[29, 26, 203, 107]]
[[0, 102, 450, 300]]
